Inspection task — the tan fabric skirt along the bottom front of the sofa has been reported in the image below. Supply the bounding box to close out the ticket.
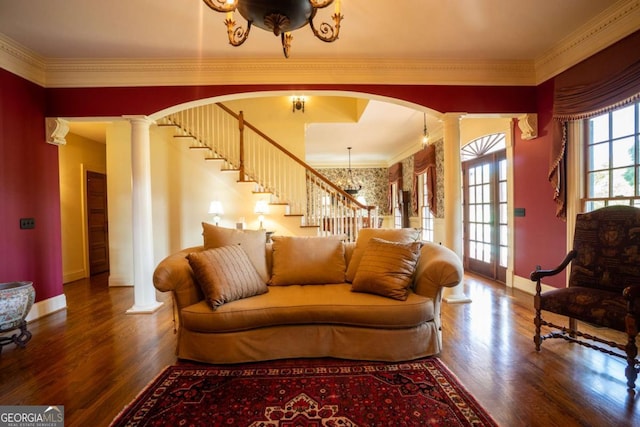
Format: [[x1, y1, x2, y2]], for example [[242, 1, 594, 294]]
[[177, 322, 442, 364]]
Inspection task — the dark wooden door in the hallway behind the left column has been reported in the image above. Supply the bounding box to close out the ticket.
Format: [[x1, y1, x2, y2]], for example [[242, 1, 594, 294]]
[[86, 171, 109, 276]]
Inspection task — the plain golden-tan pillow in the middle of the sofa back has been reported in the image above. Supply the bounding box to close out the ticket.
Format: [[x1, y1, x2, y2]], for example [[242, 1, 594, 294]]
[[270, 236, 347, 285]]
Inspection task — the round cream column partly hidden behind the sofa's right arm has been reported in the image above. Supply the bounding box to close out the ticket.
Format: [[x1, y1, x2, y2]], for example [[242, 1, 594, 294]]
[[443, 113, 471, 303]]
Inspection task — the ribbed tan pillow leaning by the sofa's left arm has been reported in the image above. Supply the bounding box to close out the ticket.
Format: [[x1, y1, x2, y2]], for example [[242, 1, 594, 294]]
[[187, 245, 268, 310]]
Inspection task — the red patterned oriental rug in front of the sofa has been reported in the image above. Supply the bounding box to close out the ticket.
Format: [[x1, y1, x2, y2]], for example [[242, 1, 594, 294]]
[[111, 358, 497, 427]]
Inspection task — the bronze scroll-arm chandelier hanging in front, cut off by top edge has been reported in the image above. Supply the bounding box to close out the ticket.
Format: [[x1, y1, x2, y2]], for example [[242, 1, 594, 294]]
[[202, 0, 343, 58]]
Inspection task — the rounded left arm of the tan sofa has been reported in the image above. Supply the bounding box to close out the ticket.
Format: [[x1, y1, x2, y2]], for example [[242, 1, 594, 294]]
[[153, 246, 204, 309]]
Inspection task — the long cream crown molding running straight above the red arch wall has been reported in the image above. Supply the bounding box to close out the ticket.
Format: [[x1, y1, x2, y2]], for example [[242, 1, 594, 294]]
[[40, 59, 535, 87]]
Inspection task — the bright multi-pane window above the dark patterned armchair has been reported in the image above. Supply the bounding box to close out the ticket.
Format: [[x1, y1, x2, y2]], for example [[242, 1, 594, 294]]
[[584, 102, 640, 211]]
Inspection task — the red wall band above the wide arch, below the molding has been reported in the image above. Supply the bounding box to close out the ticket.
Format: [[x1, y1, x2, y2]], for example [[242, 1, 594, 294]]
[[46, 85, 536, 117]]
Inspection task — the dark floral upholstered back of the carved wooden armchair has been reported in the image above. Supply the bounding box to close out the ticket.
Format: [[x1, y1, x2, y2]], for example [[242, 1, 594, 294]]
[[569, 206, 640, 292]]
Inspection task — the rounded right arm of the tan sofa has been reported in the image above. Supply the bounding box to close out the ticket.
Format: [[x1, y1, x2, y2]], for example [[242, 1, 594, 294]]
[[414, 242, 464, 299]]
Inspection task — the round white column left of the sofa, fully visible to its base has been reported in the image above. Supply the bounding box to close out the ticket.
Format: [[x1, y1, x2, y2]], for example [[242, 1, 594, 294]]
[[125, 116, 162, 314]]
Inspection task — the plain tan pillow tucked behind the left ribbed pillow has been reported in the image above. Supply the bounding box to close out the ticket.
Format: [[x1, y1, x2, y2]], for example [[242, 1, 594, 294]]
[[202, 222, 269, 283]]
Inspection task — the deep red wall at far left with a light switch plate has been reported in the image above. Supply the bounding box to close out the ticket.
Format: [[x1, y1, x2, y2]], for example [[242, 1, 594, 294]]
[[0, 69, 62, 301]]
